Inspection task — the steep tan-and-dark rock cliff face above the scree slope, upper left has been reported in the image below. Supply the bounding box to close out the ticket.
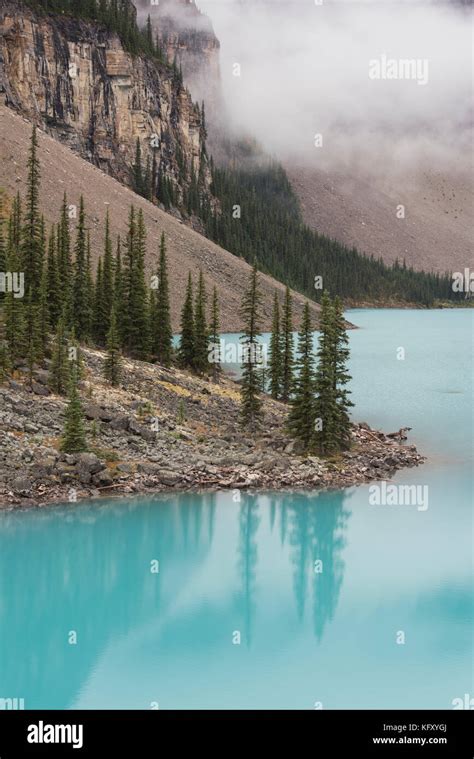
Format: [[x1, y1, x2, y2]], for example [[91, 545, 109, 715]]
[[0, 2, 210, 200]]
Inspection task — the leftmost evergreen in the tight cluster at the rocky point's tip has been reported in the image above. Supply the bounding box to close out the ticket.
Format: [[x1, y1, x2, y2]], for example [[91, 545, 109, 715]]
[[288, 301, 315, 450]]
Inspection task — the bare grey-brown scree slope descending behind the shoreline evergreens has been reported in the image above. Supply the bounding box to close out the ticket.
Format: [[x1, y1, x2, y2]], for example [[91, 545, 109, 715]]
[[0, 105, 319, 332]]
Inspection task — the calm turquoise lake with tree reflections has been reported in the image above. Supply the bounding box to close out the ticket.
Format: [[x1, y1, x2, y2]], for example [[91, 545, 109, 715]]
[[0, 309, 474, 709]]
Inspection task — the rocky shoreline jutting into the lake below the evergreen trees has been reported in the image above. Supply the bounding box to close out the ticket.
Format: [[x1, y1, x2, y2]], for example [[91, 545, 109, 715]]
[[0, 350, 425, 509]]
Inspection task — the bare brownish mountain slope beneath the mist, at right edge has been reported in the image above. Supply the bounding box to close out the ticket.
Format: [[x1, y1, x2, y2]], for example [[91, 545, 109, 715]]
[[286, 161, 474, 272]]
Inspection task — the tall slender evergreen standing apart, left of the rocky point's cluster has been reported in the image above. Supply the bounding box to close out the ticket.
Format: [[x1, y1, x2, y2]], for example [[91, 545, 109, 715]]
[[240, 263, 262, 429]]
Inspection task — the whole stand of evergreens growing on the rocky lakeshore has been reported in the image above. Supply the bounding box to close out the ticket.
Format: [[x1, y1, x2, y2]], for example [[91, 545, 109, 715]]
[[0, 127, 351, 454]]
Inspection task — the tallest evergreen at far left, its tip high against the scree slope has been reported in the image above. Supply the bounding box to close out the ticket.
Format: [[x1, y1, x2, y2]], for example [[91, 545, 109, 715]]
[[21, 126, 43, 303]]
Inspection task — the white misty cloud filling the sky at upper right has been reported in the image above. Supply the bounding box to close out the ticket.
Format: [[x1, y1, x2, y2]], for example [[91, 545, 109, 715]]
[[197, 0, 472, 173]]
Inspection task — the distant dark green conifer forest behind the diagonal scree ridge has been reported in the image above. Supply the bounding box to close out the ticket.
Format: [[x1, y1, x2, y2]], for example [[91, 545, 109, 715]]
[[205, 163, 461, 305]]
